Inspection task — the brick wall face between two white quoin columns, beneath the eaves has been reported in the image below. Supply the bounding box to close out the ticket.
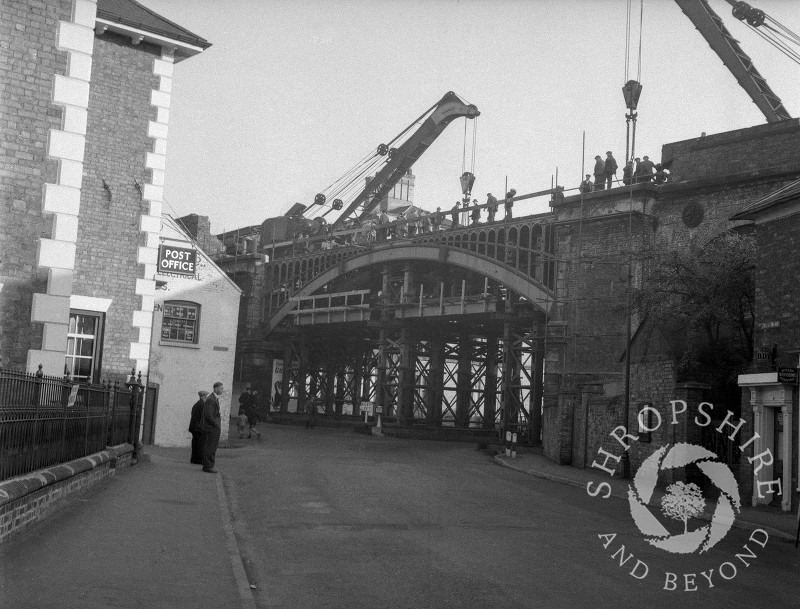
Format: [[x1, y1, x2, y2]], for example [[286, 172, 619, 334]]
[[73, 32, 161, 376]]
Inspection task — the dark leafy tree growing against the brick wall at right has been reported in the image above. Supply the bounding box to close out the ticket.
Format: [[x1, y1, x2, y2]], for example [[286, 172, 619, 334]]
[[633, 232, 756, 391]]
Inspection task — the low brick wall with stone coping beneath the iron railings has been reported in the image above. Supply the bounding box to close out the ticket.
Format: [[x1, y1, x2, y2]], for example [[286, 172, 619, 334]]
[[0, 444, 133, 544]]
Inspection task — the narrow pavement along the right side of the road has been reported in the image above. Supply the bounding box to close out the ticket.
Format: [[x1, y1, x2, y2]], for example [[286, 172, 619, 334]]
[[494, 453, 798, 541]]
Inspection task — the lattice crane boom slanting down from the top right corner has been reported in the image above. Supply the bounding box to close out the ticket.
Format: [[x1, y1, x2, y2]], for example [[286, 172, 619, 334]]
[[675, 0, 791, 123]]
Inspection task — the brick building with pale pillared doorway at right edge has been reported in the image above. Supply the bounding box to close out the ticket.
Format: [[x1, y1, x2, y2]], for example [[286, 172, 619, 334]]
[[733, 180, 800, 511]]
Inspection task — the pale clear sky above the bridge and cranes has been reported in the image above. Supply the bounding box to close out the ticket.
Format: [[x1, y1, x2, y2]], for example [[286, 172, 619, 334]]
[[140, 0, 800, 233]]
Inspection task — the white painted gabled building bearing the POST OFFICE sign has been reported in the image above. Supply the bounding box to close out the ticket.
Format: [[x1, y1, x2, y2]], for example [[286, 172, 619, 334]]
[[144, 216, 241, 446]]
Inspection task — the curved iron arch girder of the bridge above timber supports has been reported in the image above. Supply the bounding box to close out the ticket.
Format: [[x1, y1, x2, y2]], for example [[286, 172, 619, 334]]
[[267, 244, 555, 333]]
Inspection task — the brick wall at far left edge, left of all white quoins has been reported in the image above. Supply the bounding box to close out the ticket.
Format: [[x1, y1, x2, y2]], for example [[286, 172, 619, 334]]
[[0, 0, 72, 368]]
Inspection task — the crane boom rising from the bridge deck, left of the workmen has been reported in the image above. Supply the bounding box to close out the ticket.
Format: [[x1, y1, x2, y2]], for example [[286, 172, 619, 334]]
[[333, 91, 480, 228]]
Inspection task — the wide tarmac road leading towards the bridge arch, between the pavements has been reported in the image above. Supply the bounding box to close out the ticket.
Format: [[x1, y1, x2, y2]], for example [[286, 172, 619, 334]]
[[218, 426, 800, 609]]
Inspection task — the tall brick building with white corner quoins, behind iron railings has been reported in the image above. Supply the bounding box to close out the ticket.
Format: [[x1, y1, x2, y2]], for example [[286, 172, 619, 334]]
[[0, 0, 210, 381]]
